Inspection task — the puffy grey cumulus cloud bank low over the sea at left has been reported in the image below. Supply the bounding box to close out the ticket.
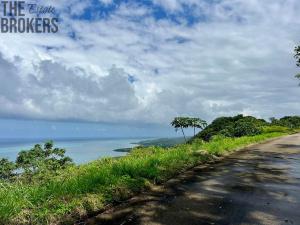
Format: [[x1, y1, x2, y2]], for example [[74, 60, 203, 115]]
[[0, 59, 138, 121]]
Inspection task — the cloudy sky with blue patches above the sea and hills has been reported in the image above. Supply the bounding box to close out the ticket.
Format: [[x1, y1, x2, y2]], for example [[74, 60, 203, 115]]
[[0, 0, 300, 137]]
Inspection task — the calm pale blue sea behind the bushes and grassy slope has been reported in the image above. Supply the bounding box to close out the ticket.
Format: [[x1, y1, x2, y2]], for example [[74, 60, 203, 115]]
[[0, 138, 151, 164]]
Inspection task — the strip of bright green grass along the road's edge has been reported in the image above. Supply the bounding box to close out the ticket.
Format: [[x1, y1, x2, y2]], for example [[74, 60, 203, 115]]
[[0, 131, 294, 224]]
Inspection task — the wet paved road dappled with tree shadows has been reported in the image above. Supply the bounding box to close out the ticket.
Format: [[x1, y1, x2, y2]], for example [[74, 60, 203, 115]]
[[86, 134, 300, 225]]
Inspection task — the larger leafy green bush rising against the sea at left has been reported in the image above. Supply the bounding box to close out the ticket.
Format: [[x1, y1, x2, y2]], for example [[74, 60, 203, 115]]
[[16, 141, 72, 175]]
